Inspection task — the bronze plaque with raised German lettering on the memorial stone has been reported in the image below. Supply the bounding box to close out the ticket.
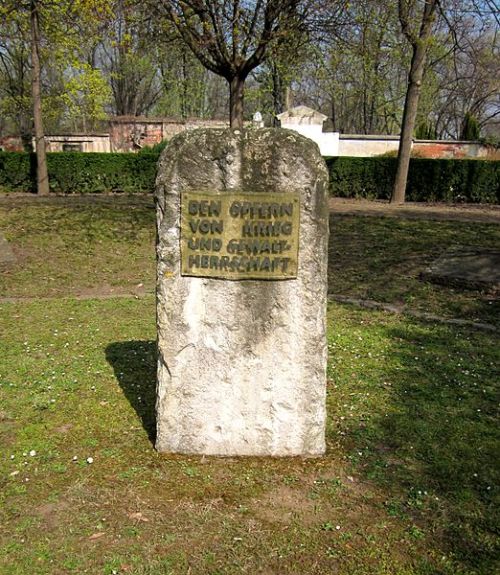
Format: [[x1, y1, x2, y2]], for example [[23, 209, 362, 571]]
[[181, 192, 300, 280]]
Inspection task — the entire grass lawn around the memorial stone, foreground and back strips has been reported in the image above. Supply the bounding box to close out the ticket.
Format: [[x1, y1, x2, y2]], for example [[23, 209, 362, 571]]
[[0, 197, 499, 575]]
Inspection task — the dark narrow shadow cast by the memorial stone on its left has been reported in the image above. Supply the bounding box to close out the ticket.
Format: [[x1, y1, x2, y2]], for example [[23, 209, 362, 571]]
[[106, 341, 156, 445]]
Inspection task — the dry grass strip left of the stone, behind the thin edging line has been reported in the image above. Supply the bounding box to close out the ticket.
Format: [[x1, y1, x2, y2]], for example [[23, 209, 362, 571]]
[[0, 200, 155, 297]]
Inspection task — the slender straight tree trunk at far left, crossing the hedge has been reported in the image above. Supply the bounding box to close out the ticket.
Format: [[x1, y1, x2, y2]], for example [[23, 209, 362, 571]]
[[30, 0, 49, 196]]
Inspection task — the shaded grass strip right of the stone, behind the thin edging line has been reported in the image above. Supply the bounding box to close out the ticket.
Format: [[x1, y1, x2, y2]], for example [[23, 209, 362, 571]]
[[328, 216, 500, 326]]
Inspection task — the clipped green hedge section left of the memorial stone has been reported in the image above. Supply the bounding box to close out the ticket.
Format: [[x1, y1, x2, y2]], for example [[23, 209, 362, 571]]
[[0, 152, 159, 194]]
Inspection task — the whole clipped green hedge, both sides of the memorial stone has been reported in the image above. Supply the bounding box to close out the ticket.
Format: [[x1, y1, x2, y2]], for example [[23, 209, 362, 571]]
[[0, 152, 500, 204]]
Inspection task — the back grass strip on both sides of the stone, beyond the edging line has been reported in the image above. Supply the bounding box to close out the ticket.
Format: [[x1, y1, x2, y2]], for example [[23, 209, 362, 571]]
[[0, 202, 500, 325]]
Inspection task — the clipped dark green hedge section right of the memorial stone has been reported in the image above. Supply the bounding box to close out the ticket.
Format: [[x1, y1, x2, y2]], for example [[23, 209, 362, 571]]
[[327, 157, 500, 204]]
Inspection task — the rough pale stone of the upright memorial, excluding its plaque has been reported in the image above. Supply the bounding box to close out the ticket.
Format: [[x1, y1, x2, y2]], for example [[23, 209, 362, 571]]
[[156, 129, 328, 456]]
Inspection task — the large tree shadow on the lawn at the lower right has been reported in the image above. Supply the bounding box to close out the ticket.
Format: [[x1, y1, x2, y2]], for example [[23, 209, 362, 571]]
[[330, 322, 500, 574]]
